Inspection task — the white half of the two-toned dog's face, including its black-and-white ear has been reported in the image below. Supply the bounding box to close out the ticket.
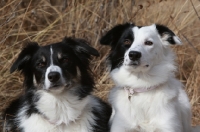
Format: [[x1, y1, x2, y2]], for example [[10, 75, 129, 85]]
[[124, 24, 181, 72]]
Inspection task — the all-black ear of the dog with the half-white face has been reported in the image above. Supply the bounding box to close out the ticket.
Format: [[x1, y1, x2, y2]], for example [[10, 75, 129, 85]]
[[100, 23, 134, 46]]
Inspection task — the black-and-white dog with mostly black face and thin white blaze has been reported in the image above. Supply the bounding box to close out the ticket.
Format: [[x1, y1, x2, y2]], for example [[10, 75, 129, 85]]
[[6, 38, 111, 132]]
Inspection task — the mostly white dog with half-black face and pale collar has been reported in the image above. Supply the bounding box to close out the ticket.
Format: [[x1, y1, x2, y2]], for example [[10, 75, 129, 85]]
[[100, 23, 200, 132]]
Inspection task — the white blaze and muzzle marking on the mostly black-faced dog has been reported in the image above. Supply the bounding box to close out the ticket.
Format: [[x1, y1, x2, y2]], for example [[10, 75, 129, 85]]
[[44, 46, 62, 89]]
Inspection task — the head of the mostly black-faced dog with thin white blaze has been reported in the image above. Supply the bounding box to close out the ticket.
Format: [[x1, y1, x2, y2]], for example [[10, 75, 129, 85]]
[[10, 38, 99, 94]]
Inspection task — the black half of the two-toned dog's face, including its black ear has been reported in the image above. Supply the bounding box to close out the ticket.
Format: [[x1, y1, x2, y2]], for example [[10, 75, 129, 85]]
[[100, 23, 134, 70]]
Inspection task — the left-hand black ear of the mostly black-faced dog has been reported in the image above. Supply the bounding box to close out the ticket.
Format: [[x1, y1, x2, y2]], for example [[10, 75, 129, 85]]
[[10, 42, 39, 73]]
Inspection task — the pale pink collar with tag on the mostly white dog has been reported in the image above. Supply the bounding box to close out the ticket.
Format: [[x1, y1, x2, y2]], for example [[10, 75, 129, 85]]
[[124, 83, 164, 99]]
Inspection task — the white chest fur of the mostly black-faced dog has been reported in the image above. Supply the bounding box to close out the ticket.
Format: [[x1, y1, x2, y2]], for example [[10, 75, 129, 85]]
[[19, 91, 95, 132]]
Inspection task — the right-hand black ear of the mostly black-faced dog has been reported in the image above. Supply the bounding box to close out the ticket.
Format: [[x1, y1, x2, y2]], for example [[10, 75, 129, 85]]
[[63, 37, 99, 56]]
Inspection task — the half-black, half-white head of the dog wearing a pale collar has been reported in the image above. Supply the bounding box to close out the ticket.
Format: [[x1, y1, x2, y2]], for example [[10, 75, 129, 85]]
[[100, 23, 181, 72]]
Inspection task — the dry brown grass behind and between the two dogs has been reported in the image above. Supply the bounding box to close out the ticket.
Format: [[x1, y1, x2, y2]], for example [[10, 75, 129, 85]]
[[0, 0, 200, 128]]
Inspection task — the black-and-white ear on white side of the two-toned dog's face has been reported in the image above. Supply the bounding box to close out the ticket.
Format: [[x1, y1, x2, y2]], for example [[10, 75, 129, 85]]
[[156, 24, 181, 45]]
